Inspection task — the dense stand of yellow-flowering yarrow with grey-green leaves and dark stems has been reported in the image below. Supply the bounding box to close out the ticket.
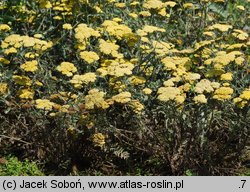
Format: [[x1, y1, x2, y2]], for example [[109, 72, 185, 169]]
[[0, 0, 250, 175]]
